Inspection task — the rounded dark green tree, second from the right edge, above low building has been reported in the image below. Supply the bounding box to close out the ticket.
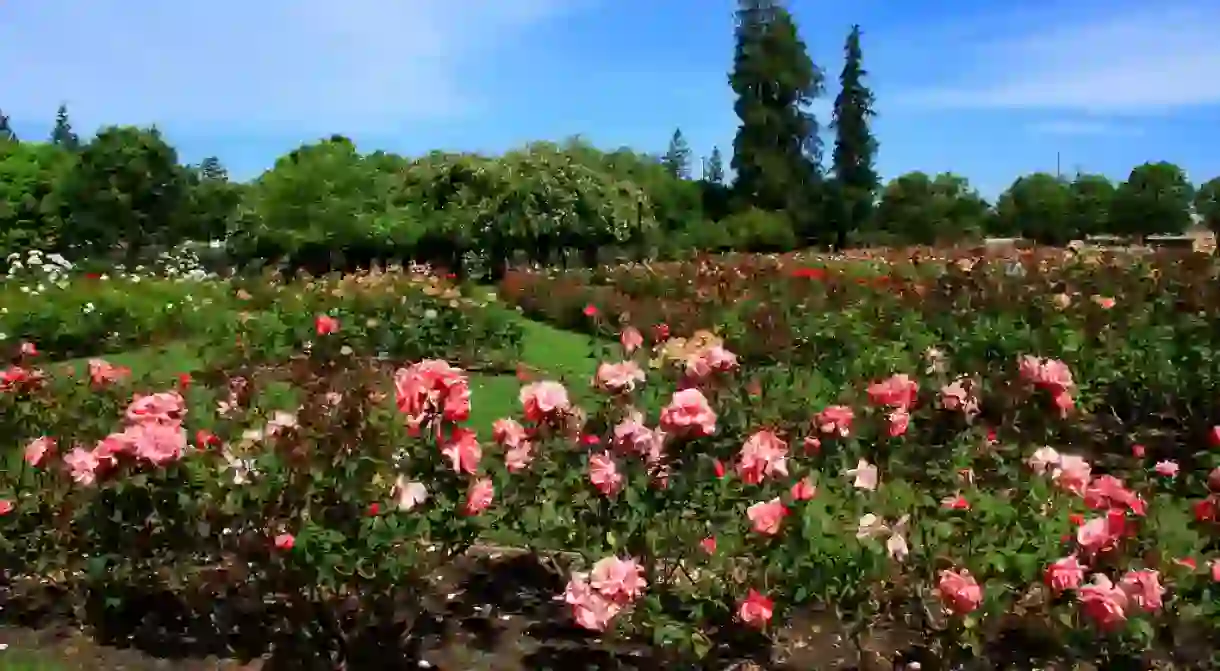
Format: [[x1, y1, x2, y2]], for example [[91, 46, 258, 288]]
[[1110, 161, 1194, 235]]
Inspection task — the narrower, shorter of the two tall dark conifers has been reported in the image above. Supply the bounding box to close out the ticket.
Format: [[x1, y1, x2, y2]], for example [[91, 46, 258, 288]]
[[831, 26, 880, 249]]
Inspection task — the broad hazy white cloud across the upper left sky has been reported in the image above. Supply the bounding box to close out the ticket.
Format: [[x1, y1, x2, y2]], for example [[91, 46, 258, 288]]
[[0, 0, 573, 132]]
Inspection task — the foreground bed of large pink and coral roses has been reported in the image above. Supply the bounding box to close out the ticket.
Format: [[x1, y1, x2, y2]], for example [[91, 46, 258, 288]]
[[0, 312, 1220, 669]]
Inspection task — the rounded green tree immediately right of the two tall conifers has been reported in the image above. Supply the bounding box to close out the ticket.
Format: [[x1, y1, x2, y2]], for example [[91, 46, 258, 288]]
[[877, 172, 988, 244]]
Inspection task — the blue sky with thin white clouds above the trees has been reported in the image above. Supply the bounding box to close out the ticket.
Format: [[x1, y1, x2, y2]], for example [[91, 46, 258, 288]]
[[0, 0, 1220, 195]]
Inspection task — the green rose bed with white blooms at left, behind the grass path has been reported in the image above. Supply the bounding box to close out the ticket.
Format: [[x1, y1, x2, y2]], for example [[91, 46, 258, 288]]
[[0, 271, 521, 370]]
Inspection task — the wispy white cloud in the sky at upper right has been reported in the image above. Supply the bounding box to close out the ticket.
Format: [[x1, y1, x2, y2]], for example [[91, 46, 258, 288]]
[[903, 1, 1220, 113]]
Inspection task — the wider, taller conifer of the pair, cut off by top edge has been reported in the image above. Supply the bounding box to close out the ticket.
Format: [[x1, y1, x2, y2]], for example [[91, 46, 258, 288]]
[[728, 0, 825, 233]]
